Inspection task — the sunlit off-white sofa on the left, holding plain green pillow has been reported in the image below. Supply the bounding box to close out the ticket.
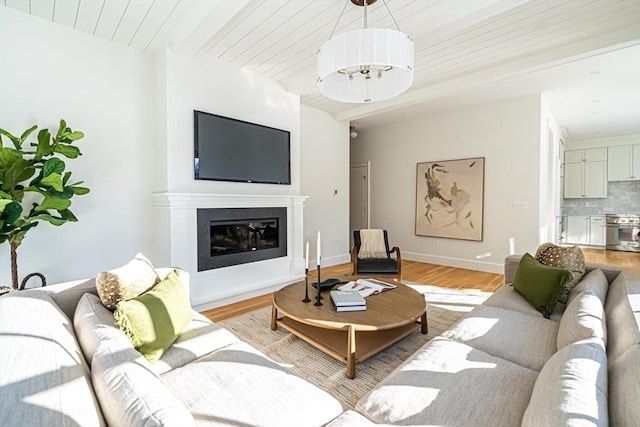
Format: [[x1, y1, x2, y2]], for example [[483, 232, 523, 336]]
[[0, 269, 343, 427]]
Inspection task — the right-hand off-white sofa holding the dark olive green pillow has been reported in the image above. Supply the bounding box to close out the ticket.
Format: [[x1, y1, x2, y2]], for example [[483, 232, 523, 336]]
[[330, 256, 640, 427]]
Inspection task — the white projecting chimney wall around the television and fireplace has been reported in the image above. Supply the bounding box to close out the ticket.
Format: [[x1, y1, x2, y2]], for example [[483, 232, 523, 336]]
[[152, 51, 303, 310]]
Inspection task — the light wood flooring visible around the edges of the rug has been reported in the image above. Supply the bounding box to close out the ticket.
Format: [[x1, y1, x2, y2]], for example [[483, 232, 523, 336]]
[[202, 248, 640, 322]]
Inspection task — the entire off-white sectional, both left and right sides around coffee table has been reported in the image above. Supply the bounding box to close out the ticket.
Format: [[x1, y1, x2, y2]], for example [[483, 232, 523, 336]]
[[0, 257, 640, 427]]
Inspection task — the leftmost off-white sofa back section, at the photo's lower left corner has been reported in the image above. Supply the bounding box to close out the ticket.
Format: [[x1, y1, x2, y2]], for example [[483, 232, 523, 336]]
[[0, 290, 105, 427]]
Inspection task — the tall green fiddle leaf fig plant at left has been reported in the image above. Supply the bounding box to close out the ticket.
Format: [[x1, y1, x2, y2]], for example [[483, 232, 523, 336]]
[[0, 120, 89, 289]]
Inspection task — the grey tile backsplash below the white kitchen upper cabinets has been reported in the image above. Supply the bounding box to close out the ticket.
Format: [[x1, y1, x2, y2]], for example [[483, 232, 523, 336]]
[[562, 181, 640, 215]]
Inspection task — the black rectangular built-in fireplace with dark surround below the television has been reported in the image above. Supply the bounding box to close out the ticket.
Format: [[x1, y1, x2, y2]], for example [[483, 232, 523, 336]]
[[197, 208, 287, 271]]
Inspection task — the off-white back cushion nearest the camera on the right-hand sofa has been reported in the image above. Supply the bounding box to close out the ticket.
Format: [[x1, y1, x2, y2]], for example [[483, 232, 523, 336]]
[[522, 340, 608, 427]]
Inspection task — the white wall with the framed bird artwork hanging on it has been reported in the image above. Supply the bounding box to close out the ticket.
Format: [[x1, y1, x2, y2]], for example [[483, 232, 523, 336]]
[[351, 95, 542, 273]]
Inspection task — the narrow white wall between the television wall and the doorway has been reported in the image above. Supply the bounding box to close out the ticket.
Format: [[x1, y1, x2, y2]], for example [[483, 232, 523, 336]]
[[300, 106, 349, 268]]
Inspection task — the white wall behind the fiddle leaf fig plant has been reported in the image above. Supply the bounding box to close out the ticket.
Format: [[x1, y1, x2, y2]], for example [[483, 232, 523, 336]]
[[0, 7, 156, 284]]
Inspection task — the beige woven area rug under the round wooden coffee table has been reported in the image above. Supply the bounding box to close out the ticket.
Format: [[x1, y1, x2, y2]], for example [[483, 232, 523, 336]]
[[219, 283, 491, 409]]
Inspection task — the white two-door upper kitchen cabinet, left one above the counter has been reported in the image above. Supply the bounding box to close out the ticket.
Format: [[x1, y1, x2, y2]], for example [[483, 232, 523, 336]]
[[564, 148, 607, 199]]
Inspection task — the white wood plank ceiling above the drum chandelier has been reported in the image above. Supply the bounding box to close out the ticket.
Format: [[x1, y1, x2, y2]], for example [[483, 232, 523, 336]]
[[5, 0, 640, 137]]
